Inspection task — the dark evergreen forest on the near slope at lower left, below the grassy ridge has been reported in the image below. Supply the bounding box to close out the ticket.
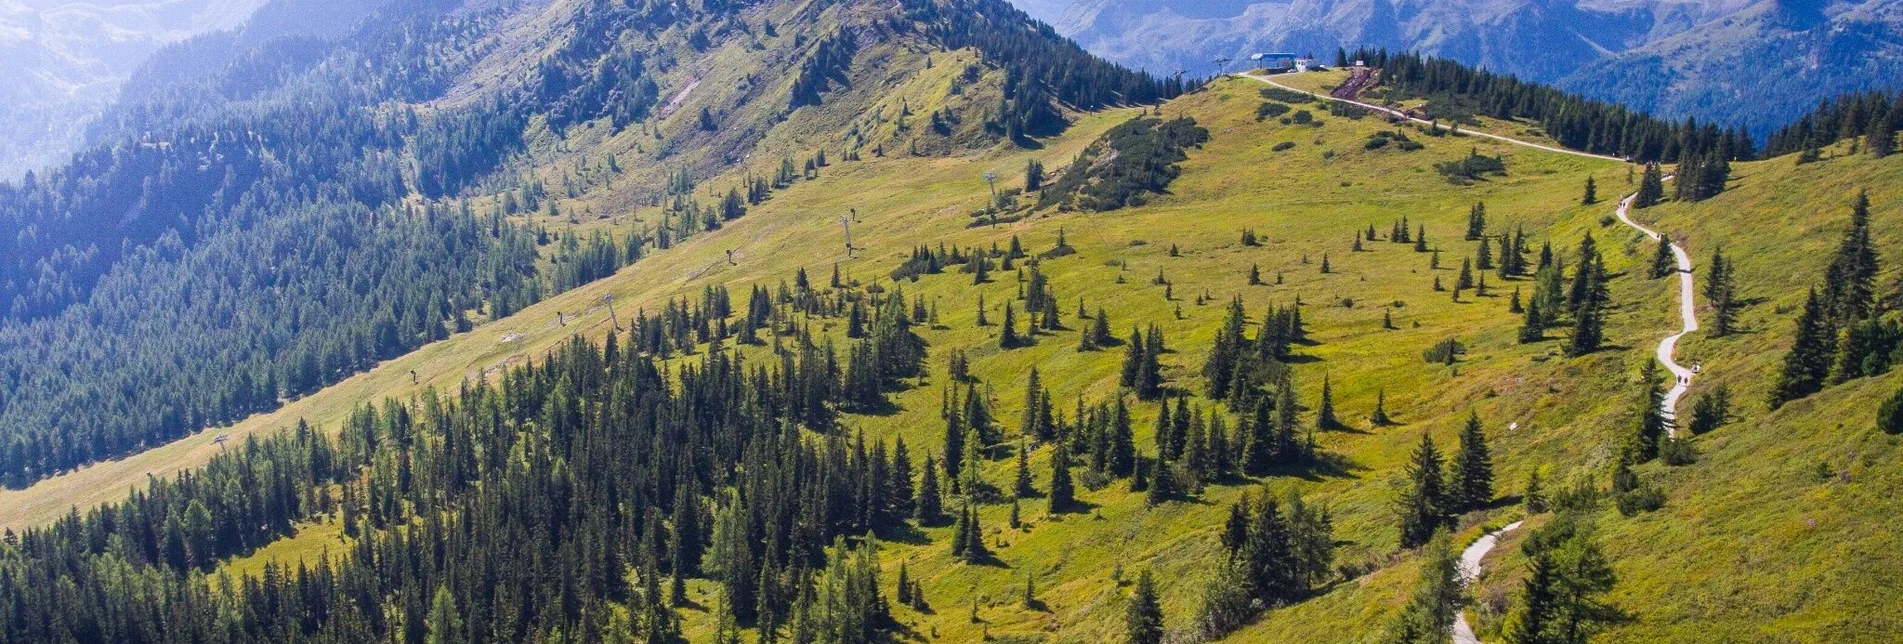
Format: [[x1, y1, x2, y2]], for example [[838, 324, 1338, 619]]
[[0, 240, 1354, 642]]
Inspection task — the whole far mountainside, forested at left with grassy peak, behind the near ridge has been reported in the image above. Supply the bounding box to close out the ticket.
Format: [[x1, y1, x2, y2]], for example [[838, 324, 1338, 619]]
[[0, 2, 1180, 488]]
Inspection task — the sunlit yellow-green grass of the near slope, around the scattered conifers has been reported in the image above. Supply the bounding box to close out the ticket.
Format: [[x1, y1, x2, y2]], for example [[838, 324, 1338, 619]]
[[0, 65, 1903, 642]]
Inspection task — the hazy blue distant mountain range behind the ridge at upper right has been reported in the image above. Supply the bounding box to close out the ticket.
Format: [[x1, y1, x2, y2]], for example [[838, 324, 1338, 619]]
[[1014, 0, 1903, 135]]
